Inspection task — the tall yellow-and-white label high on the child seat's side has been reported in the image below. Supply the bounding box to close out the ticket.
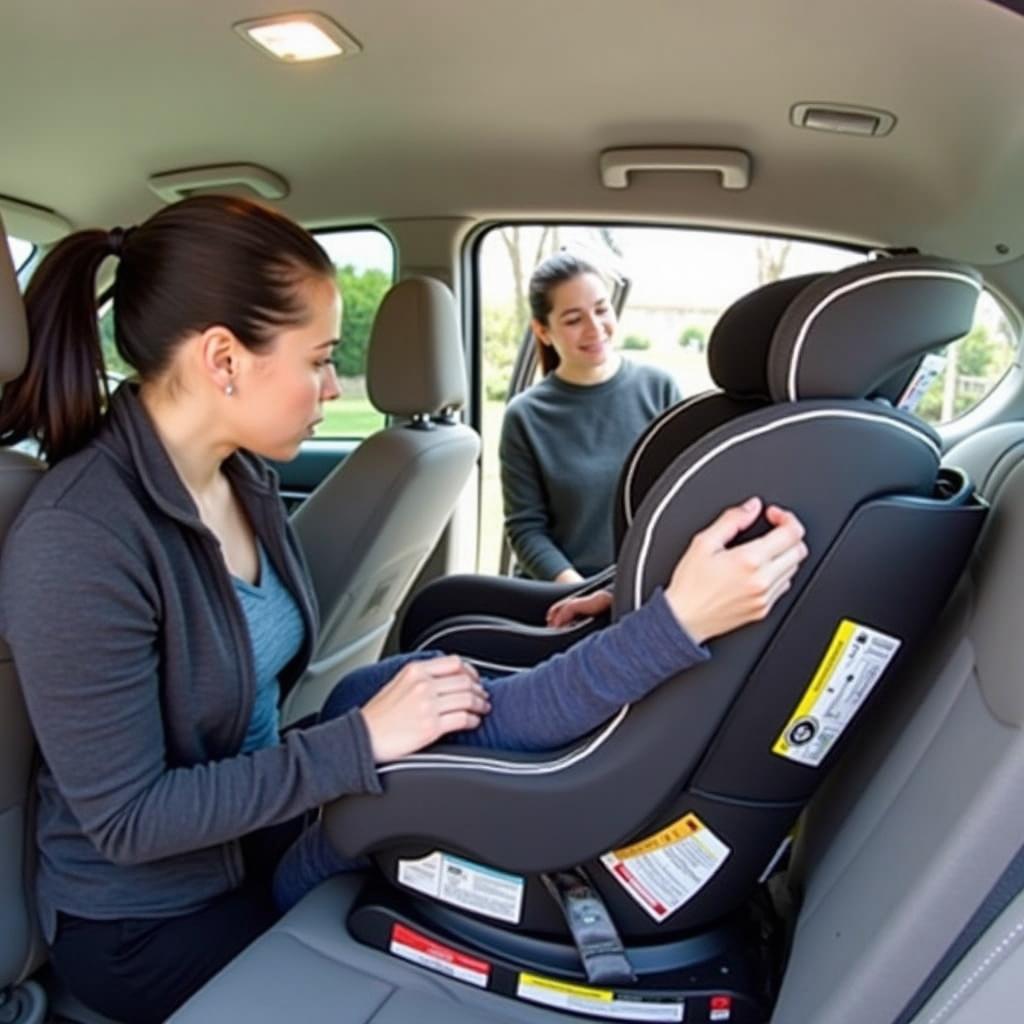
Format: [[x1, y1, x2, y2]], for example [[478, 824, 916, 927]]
[[772, 618, 901, 768]]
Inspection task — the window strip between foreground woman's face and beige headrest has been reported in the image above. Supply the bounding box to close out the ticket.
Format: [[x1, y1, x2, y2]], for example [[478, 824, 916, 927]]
[[316, 228, 395, 438]]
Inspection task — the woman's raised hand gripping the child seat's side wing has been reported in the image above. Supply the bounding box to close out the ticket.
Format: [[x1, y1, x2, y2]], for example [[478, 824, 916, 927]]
[[665, 498, 807, 643]]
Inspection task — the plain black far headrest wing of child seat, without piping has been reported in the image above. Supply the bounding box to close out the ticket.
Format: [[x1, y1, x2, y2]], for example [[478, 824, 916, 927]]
[[708, 273, 823, 400]]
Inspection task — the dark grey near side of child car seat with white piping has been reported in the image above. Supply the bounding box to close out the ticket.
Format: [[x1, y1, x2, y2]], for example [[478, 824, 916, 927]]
[[309, 257, 984, 1015]]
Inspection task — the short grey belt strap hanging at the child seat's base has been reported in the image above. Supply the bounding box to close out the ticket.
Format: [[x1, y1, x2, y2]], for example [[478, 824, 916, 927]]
[[541, 868, 636, 985]]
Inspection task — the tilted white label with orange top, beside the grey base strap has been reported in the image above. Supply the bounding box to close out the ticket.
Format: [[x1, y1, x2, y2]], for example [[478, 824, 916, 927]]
[[601, 814, 730, 923]]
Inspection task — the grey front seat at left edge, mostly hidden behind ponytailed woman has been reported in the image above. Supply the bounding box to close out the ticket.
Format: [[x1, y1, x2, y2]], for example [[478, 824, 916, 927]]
[[0, 222, 44, 992]]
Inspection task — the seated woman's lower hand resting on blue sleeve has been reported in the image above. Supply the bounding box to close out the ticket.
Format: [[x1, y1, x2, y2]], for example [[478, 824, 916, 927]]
[[361, 654, 490, 764]]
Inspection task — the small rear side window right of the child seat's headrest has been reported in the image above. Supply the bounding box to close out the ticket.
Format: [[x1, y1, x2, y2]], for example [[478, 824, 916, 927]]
[[903, 292, 1020, 425]]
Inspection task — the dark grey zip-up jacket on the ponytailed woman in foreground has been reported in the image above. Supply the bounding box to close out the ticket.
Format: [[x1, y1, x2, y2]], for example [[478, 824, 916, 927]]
[[0, 385, 380, 941]]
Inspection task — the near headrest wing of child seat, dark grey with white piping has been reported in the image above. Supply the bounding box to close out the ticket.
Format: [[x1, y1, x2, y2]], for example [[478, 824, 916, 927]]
[[768, 256, 982, 401]]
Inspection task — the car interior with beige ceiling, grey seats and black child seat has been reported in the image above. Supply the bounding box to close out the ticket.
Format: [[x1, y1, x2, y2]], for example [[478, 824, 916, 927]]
[[0, 0, 1024, 1024]]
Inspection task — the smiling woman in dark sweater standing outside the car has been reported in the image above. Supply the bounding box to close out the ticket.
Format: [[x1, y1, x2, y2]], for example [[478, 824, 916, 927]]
[[499, 253, 681, 583]]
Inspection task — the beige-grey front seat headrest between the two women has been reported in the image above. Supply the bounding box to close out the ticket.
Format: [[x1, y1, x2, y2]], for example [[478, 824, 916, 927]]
[[366, 278, 466, 417]]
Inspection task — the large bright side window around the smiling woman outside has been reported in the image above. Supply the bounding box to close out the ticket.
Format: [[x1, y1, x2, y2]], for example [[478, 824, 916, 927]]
[[477, 224, 864, 572]]
